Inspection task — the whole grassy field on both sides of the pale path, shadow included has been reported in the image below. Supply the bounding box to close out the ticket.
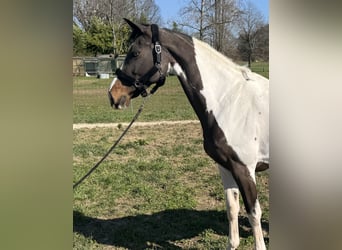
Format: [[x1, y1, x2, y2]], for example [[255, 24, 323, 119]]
[[73, 62, 269, 249]]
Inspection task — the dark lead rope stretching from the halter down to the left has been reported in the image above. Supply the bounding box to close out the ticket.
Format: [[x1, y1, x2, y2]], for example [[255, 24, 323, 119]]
[[72, 94, 152, 189]]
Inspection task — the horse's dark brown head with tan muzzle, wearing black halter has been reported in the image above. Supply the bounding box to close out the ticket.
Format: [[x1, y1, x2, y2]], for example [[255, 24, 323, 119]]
[[108, 19, 172, 109]]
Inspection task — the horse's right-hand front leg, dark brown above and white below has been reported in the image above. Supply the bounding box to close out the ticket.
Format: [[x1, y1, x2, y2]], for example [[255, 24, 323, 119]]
[[232, 163, 266, 250]]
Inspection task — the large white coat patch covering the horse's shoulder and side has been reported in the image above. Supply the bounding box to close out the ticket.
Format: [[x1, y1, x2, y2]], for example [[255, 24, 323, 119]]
[[193, 38, 269, 167]]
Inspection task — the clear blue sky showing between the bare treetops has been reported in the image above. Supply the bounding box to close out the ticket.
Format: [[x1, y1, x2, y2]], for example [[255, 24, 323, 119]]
[[155, 0, 269, 25]]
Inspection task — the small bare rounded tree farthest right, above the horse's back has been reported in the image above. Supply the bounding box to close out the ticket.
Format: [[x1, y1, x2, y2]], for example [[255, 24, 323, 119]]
[[238, 1, 264, 67]]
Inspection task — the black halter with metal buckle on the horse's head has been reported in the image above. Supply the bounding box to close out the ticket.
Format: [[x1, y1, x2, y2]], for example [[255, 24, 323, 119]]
[[115, 24, 165, 97]]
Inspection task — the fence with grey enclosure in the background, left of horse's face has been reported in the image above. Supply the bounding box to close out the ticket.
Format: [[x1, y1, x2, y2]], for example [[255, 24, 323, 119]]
[[72, 55, 125, 76]]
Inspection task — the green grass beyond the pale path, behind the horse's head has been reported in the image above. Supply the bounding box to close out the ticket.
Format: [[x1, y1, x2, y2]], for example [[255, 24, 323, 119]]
[[73, 62, 268, 123]]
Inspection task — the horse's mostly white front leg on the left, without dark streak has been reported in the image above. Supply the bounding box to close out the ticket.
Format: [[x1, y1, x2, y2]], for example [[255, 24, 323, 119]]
[[218, 165, 240, 250]]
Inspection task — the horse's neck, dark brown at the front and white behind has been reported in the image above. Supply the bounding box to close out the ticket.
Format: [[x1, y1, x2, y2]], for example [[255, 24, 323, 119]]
[[162, 32, 242, 127]]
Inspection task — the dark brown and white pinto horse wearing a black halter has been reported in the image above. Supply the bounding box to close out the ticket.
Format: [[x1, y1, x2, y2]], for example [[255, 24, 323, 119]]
[[108, 19, 269, 250]]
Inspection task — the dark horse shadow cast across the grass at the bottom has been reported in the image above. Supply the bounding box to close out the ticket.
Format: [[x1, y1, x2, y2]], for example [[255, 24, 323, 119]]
[[73, 209, 268, 249]]
